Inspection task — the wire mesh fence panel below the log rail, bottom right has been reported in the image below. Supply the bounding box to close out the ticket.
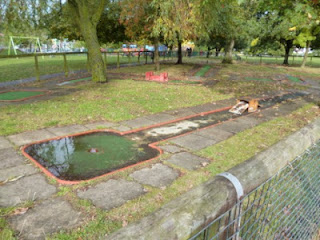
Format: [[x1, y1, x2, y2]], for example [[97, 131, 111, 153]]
[[190, 142, 320, 240]]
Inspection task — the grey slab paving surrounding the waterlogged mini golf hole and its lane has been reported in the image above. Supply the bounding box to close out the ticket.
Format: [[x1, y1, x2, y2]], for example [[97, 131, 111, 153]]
[[0, 91, 314, 239]]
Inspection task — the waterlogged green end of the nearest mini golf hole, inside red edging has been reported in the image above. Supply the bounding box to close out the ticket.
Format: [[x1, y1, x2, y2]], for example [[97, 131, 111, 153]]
[[25, 132, 159, 181]]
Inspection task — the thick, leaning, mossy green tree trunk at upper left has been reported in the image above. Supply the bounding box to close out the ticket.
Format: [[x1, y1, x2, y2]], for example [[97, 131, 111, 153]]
[[68, 0, 107, 82]]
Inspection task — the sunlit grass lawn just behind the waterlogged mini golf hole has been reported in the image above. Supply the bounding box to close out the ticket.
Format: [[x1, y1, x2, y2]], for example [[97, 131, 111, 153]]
[[0, 80, 233, 135]]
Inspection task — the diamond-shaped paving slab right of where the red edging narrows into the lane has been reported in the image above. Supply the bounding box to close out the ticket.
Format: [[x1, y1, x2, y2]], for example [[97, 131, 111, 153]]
[[170, 133, 216, 151]]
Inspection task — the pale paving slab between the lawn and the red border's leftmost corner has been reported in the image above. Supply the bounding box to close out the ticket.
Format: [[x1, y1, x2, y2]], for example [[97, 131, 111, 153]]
[[8, 129, 56, 146]]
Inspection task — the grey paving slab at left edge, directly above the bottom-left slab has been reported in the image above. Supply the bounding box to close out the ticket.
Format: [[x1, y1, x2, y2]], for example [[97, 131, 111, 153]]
[[0, 174, 56, 207]]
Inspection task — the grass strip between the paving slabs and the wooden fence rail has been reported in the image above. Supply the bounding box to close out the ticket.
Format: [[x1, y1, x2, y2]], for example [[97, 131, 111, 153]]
[[49, 104, 320, 240]]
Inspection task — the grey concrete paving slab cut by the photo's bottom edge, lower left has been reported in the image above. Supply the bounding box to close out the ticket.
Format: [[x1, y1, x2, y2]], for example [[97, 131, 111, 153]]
[[8, 198, 83, 240]]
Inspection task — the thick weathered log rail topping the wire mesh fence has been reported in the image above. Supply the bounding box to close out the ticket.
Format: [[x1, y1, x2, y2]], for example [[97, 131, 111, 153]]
[[107, 119, 320, 240]]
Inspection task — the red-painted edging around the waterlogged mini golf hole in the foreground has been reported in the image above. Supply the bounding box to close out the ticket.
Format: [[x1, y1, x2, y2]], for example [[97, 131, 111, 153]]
[[21, 106, 234, 185]]
